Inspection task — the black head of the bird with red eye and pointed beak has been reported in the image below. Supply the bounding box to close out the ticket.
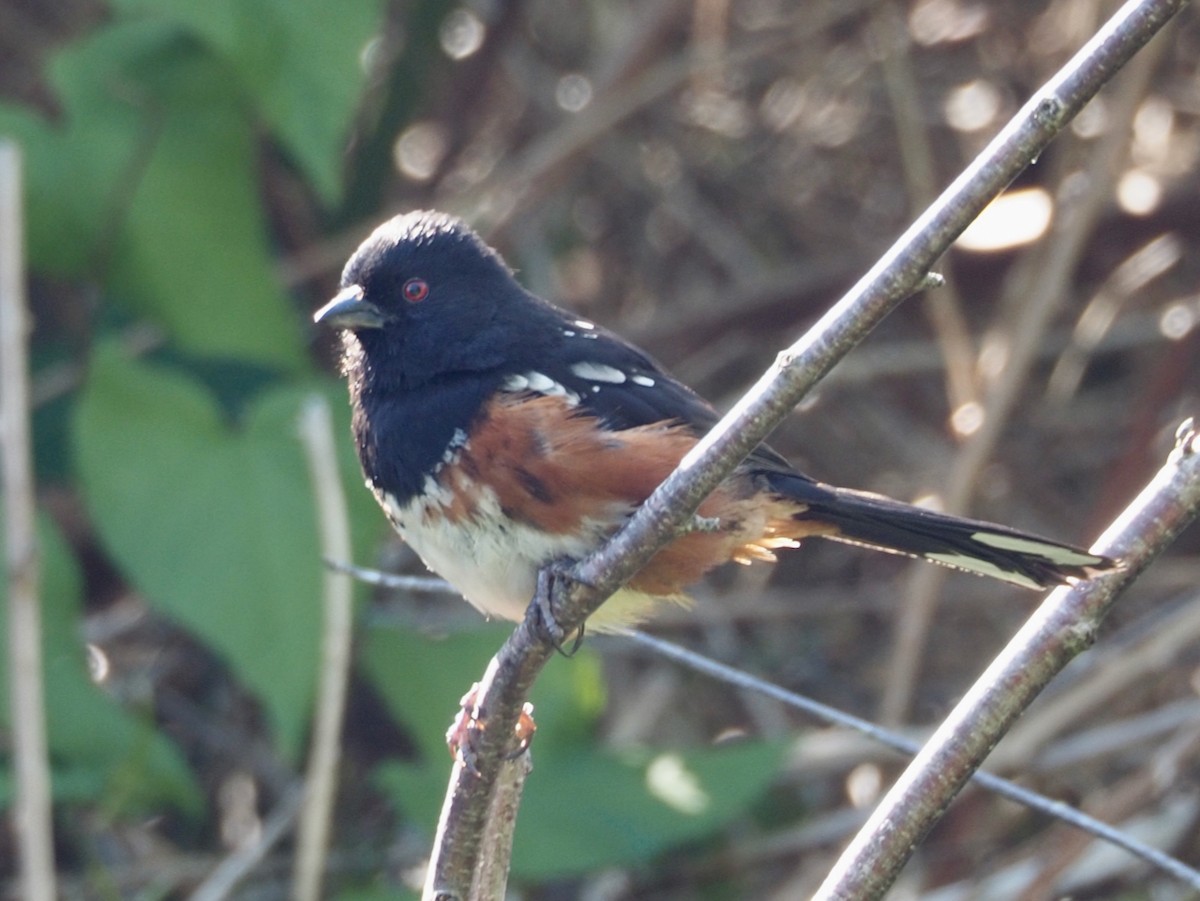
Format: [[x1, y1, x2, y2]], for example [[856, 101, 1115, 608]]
[[313, 211, 552, 389]]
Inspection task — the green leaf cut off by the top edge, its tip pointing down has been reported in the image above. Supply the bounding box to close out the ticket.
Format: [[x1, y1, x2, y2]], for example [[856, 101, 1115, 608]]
[[116, 0, 383, 203]]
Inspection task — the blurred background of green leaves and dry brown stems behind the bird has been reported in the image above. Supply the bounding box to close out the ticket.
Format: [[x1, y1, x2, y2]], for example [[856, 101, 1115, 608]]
[[0, 0, 1200, 899]]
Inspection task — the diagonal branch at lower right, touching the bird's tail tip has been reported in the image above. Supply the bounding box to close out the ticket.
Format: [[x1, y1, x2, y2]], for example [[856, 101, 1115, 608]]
[[815, 420, 1200, 901]]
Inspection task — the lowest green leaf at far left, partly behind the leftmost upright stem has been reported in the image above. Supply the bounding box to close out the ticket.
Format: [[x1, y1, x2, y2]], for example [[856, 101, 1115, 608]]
[[0, 511, 200, 813]]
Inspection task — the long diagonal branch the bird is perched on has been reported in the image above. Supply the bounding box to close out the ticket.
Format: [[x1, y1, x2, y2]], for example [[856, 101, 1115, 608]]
[[425, 0, 1186, 901]]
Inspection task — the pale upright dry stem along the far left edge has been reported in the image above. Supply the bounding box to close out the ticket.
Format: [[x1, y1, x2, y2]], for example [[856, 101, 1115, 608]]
[[0, 140, 56, 901]]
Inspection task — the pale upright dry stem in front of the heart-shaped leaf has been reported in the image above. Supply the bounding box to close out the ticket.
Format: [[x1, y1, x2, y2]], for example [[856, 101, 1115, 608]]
[[292, 395, 353, 901]]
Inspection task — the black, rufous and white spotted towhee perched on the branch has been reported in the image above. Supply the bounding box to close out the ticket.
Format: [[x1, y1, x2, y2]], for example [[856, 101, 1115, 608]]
[[314, 212, 1116, 630]]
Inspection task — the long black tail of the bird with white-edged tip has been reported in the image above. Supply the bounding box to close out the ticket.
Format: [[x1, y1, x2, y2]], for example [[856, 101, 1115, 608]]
[[768, 473, 1120, 588]]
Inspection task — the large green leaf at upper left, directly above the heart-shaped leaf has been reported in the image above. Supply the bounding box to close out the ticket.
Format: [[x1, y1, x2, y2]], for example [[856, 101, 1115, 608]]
[[0, 22, 307, 371]]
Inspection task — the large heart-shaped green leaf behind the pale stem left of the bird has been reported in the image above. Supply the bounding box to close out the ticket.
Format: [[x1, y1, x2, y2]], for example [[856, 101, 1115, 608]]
[[76, 346, 380, 755]]
